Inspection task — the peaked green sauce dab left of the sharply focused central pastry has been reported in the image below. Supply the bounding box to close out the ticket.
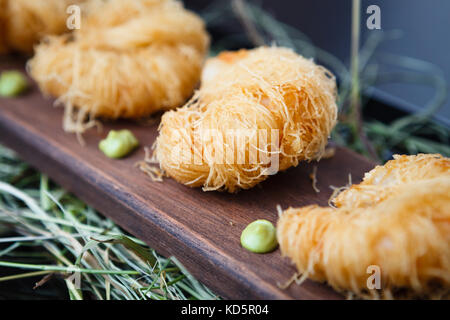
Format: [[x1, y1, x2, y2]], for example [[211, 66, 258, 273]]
[[98, 130, 139, 158]]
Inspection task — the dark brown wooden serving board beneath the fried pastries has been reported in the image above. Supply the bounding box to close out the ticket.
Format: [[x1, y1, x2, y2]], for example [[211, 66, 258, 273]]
[[0, 56, 373, 299]]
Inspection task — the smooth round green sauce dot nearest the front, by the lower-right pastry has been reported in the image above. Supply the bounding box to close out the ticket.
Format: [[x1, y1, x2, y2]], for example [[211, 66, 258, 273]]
[[241, 219, 278, 253]]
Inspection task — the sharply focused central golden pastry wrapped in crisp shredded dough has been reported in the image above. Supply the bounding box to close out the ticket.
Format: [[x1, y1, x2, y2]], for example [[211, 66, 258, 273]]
[[155, 47, 337, 192]]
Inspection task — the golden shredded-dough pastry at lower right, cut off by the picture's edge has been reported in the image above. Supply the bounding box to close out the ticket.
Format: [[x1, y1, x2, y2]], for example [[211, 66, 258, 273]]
[[277, 154, 450, 297]]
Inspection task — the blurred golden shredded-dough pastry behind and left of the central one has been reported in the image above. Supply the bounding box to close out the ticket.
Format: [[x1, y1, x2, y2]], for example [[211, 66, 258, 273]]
[[29, 0, 209, 131]]
